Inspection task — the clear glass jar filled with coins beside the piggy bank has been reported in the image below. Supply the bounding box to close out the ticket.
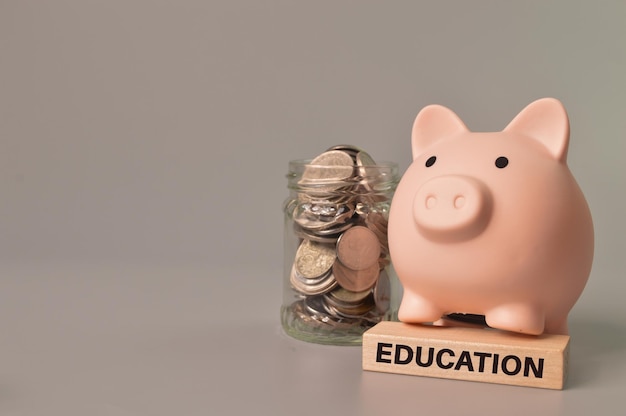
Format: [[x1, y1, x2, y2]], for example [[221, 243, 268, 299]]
[[281, 145, 400, 345]]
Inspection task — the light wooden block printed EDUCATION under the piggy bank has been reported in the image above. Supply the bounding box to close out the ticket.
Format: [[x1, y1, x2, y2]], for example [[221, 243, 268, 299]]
[[363, 322, 570, 389]]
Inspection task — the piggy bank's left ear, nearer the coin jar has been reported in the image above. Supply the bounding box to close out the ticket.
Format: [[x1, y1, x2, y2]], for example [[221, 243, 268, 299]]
[[411, 105, 468, 160]]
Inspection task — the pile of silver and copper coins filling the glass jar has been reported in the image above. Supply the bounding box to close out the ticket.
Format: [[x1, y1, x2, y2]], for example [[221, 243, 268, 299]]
[[288, 145, 391, 328]]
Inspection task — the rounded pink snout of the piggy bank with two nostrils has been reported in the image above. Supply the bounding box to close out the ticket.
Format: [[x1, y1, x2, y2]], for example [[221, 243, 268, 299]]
[[413, 175, 491, 242]]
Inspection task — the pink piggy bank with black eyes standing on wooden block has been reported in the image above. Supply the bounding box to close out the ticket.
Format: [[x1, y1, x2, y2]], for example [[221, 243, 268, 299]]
[[388, 98, 593, 334]]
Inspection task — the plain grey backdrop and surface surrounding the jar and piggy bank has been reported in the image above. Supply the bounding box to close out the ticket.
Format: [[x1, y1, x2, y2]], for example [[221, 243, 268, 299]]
[[0, 0, 626, 416]]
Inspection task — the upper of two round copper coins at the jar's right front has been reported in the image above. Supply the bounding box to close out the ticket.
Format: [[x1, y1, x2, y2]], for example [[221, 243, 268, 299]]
[[337, 225, 381, 270]]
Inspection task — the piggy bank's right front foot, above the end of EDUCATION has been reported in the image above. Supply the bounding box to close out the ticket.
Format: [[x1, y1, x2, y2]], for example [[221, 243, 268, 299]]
[[485, 304, 546, 335]]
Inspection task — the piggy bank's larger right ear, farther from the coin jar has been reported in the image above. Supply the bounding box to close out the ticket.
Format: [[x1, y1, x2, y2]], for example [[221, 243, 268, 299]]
[[504, 98, 569, 163]]
